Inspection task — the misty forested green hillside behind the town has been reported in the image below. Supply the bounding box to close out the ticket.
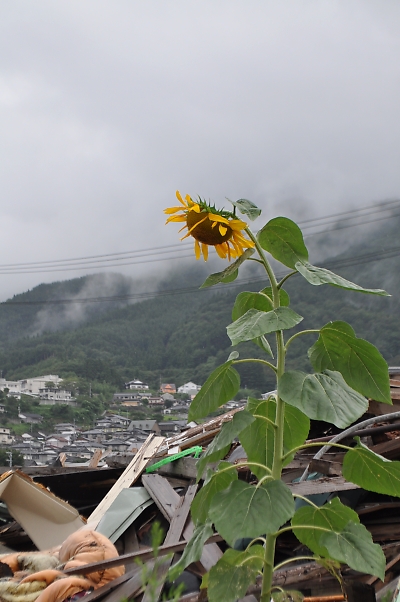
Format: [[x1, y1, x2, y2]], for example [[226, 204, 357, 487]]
[[0, 213, 400, 391]]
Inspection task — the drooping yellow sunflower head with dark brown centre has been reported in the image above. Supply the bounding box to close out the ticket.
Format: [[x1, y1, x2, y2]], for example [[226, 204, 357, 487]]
[[164, 190, 254, 261]]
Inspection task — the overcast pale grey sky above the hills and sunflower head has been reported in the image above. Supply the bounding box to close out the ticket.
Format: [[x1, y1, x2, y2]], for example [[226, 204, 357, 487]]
[[0, 0, 400, 300]]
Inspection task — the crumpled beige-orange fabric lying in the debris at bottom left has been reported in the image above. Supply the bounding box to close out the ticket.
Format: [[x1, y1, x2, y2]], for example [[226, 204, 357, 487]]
[[0, 530, 125, 602]]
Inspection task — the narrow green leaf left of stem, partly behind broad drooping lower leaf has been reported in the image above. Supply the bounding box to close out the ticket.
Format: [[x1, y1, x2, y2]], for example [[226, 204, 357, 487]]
[[190, 462, 238, 525]]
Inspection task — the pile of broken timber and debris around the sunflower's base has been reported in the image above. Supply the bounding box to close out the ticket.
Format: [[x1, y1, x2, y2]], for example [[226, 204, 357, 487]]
[[0, 394, 400, 602]]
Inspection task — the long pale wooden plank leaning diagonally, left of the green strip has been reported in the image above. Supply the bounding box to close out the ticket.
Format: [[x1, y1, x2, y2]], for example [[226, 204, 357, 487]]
[[87, 434, 164, 529]]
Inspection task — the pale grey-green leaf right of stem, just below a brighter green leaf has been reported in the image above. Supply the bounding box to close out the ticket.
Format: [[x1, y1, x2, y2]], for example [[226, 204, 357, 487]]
[[279, 370, 368, 428]]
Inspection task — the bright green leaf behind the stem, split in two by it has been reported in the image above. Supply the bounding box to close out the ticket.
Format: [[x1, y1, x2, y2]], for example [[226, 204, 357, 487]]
[[239, 398, 310, 479]]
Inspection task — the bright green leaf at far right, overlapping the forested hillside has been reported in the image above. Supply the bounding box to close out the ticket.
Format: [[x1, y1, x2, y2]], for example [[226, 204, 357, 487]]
[[308, 321, 392, 404]]
